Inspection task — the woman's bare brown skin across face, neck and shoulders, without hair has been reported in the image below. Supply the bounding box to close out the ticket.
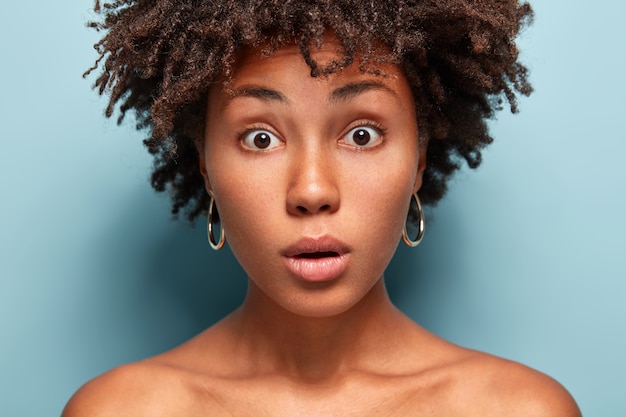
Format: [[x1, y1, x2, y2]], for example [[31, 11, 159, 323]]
[[63, 39, 580, 417]]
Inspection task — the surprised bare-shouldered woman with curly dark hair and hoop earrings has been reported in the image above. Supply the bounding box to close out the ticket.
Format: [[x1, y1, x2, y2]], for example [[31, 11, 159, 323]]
[[64, 0, 580, 417]]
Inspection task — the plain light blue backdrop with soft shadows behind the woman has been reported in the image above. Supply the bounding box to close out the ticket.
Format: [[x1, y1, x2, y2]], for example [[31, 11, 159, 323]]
[[0, 0, 626, 417]]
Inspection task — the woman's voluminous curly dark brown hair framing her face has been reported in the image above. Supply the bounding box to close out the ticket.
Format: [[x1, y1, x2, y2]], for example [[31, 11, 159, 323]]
[[85, 0, 533, 220]]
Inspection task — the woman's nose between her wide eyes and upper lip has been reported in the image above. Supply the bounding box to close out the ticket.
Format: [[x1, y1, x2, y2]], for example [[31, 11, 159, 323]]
[[287, 149, 340, 216]]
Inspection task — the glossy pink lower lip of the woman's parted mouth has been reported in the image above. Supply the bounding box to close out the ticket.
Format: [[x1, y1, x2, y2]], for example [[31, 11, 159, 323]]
[[285, 254, 348, 282]]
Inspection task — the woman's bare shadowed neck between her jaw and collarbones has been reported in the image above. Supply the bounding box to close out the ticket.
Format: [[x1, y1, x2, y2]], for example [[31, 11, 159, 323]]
[[231, 278, 408, 381]]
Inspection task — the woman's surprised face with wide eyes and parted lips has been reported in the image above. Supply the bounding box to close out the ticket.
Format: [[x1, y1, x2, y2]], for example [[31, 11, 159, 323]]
[[200, 38, 425, 317]]
